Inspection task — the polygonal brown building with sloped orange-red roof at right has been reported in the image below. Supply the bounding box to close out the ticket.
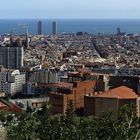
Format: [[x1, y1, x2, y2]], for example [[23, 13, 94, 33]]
[[84, 86, 137, 119]]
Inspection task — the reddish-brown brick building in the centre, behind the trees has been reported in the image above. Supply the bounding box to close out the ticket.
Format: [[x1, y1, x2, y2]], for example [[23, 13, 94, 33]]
[[49, 80, 96, 114]]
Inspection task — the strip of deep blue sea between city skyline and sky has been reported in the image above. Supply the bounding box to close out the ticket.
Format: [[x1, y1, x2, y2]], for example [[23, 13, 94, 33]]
[[0, 19, 140, 35]]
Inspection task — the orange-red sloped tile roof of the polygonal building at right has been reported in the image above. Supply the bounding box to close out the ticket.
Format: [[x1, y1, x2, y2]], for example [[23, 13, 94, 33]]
[[95, 86, 138, 99]]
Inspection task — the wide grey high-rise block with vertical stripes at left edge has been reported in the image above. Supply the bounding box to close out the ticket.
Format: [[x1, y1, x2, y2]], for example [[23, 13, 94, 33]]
[[0, 47, 24, 68]]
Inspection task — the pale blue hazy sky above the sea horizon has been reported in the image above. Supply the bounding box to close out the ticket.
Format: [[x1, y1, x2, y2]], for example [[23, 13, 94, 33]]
[[0, 0, 140, 19]]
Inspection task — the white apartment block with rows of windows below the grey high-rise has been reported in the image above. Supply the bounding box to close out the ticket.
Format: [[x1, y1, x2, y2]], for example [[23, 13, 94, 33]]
[[0, 69, 25, 96]]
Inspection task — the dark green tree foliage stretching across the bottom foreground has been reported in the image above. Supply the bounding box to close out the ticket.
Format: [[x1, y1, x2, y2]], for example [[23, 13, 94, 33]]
[[2, 103, 140, 140]]
